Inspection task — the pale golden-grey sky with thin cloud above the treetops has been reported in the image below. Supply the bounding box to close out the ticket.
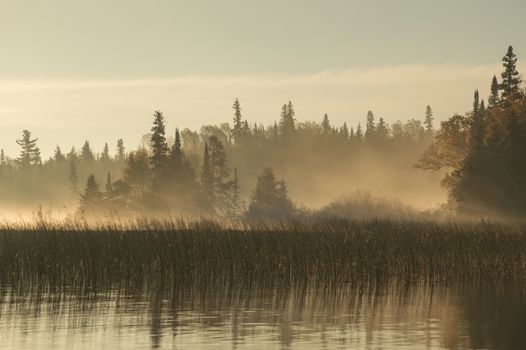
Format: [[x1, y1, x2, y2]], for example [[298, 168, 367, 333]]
[[0, 0, 526, 156]]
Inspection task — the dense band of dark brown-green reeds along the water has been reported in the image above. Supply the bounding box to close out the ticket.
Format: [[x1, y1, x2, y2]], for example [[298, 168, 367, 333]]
[[0, 219, 526, 288]]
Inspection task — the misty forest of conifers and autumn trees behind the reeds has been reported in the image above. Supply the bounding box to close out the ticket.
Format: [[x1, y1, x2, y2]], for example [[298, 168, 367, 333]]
[[4, 47, 526, 217]]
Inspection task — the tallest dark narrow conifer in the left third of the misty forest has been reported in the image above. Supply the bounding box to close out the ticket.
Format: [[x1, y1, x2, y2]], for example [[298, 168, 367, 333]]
[[150, 111, 169, 189]]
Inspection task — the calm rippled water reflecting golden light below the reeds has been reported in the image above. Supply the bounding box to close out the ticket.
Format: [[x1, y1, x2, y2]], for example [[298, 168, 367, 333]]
[[0, 283, 526, 350]]
